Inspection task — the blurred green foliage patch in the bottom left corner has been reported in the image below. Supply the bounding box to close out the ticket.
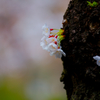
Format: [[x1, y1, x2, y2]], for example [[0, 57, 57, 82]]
[[0, 79, 28, 100]]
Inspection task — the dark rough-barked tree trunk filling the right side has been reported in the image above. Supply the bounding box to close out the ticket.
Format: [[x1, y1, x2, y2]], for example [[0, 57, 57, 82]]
[[60, 0, 100, 100]]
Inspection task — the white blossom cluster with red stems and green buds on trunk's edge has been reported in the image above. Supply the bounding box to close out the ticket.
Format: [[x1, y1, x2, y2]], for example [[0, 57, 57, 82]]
[[40, 25, 66, 58]]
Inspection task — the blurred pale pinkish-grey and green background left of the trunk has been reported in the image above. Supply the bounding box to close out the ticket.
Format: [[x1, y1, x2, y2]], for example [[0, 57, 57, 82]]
[[0, 0, 70, 100]]
